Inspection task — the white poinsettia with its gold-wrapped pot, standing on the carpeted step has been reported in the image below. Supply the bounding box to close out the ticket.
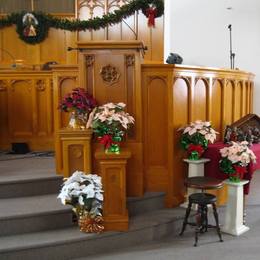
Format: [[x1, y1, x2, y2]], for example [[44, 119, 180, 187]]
[[58, 171, 104, 233]]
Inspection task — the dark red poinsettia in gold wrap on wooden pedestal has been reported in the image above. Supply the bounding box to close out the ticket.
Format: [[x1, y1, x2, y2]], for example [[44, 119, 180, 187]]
[[59, 88, 97, 129]]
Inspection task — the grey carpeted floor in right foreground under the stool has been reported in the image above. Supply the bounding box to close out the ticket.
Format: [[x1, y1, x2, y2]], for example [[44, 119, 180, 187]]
[[77, 171, 260, 260]]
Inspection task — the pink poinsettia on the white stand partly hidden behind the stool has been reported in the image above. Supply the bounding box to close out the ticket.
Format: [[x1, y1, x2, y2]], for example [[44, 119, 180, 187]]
[[179, 120, 218, 160]]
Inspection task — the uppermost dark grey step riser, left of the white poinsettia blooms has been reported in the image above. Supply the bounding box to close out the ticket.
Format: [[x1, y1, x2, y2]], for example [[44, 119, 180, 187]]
[[0, 178, 62, 199]]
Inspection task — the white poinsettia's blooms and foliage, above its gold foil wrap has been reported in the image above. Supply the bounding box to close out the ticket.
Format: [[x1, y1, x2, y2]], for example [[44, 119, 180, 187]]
[[58, 171, 103, 217]]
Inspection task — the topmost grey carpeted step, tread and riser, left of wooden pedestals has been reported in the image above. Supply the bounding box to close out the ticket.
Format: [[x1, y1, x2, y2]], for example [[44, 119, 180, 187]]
[[0, 158, 63, 199]]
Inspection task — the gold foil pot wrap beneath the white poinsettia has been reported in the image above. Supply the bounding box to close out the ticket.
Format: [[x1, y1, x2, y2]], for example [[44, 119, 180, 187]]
[[78, 215, 104, 233]]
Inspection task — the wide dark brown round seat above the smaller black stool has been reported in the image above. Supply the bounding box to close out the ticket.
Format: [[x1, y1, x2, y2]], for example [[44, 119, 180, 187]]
[[184, 177, 223, 190]]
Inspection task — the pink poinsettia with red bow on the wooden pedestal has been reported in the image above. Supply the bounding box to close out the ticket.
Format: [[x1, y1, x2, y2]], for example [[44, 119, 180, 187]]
[[90, 103, 134, 153]]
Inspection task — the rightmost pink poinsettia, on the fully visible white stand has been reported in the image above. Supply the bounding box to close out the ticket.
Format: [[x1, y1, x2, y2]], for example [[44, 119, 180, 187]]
[[219, 141, 256, 182]]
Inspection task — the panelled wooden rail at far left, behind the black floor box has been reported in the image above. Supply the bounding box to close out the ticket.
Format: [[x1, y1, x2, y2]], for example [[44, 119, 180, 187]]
[[0, 70, 54, 150]]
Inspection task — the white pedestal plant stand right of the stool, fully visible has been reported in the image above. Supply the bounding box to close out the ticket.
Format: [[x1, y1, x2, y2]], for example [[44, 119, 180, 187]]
[[221, 180, 249, 236]]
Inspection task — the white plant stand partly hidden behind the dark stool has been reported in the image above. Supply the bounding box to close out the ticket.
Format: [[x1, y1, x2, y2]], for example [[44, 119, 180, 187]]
[[180, 158, 210, 210]]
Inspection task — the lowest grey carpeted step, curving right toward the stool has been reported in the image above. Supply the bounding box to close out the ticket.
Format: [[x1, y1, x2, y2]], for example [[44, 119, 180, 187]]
[[0, 208, 185, 260]]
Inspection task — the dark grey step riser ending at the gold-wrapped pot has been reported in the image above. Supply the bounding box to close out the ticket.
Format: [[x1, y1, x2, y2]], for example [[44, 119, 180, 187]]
[[0, 211, 73, 238]]
